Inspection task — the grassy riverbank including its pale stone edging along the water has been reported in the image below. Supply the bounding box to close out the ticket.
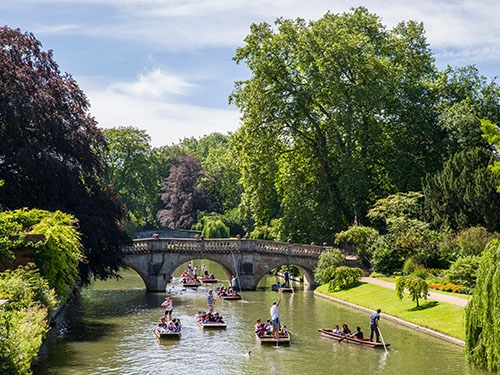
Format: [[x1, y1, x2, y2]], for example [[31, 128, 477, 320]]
[[314, 283, 464, 346]]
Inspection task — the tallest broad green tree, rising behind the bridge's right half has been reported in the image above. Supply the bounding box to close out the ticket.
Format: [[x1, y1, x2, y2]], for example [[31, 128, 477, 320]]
[[230, 7, 443, 241]]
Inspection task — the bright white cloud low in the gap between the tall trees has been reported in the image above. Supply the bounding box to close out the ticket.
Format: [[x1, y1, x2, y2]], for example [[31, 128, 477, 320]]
[[81, 71, 240, 147]]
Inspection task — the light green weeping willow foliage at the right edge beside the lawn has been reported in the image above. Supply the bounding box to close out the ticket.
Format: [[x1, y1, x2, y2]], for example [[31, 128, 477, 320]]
[[465, 240, 500, 371]]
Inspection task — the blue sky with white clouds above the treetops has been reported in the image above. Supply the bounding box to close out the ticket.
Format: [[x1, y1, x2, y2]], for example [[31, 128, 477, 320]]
[[0, 0, 500, 147]]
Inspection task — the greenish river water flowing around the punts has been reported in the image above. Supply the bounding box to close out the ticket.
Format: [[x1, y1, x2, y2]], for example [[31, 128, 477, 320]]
[[34, 264, 491, 375]]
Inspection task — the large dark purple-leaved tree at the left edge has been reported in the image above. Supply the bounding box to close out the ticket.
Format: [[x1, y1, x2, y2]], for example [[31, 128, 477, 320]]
[[0, 27, 129, 282]]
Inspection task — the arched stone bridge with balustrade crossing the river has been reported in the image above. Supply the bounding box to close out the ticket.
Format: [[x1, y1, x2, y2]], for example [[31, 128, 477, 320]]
[[122, 238, 330, 292]]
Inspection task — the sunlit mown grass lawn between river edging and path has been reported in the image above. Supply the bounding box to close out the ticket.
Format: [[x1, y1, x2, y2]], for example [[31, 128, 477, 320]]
[[316, 284, 465, 340]]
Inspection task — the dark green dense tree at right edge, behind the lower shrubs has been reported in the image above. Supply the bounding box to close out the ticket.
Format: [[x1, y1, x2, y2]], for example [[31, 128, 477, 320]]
[[423, 148, 500, 232]]
